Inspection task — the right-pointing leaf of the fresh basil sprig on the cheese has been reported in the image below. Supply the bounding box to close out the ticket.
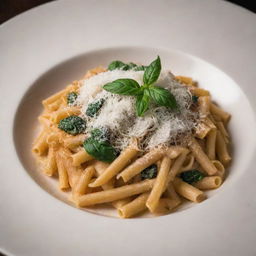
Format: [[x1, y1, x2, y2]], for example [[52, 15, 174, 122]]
[[148, 86, 178, 109]]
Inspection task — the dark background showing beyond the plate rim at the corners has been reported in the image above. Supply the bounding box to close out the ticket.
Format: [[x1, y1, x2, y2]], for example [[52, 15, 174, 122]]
[[0, 0, 256, 256]]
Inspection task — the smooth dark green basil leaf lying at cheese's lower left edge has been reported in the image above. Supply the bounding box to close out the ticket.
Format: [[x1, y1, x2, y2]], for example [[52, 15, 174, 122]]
[[83, 137, 117, 163]]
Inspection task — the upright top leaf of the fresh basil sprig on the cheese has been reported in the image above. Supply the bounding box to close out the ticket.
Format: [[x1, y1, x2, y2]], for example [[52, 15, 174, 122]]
[[143, 56, 161, 85]]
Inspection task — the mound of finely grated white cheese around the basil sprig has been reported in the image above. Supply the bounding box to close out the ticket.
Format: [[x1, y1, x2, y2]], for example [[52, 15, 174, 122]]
[[77, 70, 198, 150]]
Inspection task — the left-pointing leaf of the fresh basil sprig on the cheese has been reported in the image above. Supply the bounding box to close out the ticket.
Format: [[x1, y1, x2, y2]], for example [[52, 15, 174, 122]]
[[103, 78, 141, 96]]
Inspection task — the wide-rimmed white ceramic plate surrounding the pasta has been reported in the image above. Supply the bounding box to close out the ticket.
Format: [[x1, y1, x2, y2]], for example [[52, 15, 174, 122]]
[[0, 0, 256, 256]]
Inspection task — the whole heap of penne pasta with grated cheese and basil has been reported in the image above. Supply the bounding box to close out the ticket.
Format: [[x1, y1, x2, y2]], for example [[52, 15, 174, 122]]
[[33, 57, 231, 218]]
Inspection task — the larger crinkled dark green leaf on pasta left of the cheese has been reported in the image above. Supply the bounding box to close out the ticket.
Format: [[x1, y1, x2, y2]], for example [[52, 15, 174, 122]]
[[58, 116, 86, 135]]
